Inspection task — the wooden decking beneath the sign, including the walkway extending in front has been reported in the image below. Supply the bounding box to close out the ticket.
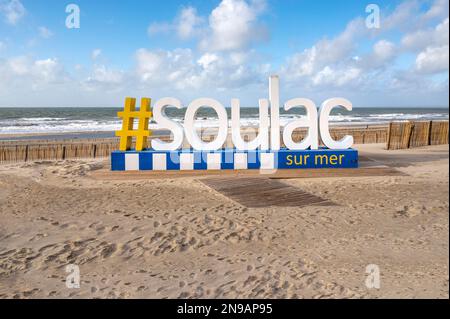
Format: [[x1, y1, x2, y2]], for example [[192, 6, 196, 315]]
[[90, 155, 406, 208]]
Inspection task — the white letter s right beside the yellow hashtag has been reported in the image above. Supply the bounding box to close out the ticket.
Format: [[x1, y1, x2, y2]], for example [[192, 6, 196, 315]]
[[152, 97, 184, 151]]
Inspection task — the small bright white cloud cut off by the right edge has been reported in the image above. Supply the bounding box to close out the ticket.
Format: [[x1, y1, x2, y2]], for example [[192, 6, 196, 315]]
[[416, 45, 449, 74]]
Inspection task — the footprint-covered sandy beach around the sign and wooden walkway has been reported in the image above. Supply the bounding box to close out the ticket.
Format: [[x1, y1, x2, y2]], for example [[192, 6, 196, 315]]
[[0, 144, 449, 298]]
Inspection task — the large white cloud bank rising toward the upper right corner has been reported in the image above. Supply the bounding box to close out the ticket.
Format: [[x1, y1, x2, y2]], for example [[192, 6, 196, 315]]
[[281, 0, 448, 96]]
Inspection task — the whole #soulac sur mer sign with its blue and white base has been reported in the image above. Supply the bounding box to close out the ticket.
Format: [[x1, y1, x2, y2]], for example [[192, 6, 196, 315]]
[[111, 76, 358, 171]]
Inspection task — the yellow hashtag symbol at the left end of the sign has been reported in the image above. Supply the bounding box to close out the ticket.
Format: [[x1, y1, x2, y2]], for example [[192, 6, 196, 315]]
[[116, 97, 152, 151]]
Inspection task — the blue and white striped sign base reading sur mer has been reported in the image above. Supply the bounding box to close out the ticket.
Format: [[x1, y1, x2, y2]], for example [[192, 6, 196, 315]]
[[111, 148, 358, 171]]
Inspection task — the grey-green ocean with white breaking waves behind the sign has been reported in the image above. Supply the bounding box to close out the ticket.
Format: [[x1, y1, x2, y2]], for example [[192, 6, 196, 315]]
[[0, 107, 449, 134]]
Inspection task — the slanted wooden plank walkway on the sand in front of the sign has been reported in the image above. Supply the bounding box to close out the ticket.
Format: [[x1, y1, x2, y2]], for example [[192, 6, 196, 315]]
[[201, 177, 335, 208]]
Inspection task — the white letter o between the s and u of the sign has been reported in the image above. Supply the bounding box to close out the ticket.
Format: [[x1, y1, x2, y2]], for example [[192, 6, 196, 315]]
[[184, 98, 228, 151]]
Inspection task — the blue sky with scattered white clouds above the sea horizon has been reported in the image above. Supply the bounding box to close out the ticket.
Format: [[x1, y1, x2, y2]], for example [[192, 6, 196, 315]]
[[0, 0, 449, 107]]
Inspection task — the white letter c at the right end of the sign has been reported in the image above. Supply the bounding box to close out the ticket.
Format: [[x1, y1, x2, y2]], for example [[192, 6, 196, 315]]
[[319, 98, 353, 150]]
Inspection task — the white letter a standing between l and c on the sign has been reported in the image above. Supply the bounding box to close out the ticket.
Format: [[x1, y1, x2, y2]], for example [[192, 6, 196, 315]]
[[283, 98, 319, 150]]
